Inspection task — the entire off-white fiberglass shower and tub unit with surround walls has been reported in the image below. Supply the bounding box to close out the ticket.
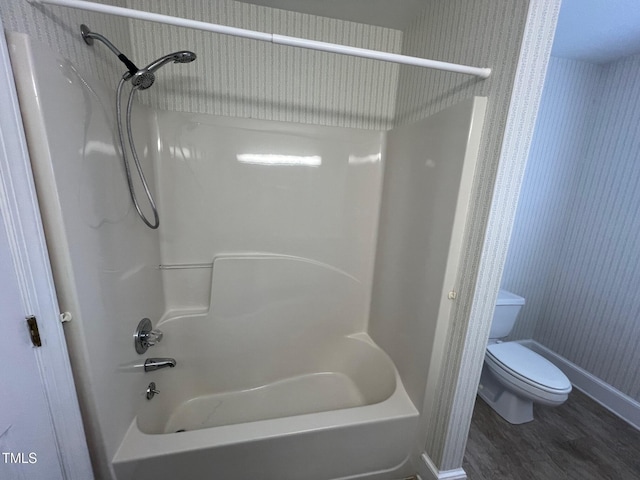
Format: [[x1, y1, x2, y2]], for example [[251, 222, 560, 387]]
[[9, 6, 486, 480]]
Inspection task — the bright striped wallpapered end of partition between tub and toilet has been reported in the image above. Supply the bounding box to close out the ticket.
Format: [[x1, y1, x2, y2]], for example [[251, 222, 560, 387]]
[[438, 0, 560, 469]]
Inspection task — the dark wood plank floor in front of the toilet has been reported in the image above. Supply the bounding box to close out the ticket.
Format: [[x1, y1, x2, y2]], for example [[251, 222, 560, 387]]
[[463, 389, 640, 480]]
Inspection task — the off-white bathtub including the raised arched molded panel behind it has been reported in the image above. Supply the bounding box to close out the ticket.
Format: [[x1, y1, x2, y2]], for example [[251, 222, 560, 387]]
[[113, 255, 418, 480]]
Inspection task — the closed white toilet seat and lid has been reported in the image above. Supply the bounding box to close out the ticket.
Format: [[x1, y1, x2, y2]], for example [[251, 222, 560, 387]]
[[485, 342, 571, 404]]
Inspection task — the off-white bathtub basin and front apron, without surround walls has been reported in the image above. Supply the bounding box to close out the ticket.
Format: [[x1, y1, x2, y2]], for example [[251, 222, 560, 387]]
[[113, 332, 418, 480]]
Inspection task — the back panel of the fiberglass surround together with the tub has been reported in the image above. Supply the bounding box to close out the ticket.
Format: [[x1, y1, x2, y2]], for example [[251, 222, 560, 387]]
[[106, 94, 418, 480]]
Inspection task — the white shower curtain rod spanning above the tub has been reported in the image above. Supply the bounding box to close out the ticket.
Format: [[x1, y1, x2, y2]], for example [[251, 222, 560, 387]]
[[27, 0, 491, 78]]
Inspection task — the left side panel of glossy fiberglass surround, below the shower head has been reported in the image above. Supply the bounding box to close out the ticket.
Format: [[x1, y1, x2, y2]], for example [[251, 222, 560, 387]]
[[10, 35, 164, 478]]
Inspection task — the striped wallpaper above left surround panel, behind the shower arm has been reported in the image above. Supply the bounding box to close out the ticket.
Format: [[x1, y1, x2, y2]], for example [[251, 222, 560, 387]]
[[0, 0, 131, 84]]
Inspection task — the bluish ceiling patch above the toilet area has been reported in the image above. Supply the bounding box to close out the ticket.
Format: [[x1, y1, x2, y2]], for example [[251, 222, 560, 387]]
[[551, 0, 640, 63]]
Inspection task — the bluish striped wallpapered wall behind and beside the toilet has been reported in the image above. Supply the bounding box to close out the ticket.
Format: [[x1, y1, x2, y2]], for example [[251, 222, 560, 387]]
[[505, 56, 640, 400]]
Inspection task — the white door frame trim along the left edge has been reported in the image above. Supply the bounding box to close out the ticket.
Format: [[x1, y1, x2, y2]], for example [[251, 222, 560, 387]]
[[0, 26, 93, 480]]
